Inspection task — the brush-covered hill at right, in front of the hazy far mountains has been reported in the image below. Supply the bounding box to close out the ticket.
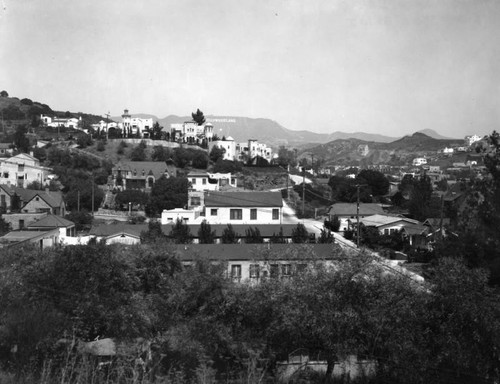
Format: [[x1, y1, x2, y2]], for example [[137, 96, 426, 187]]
[[299, 132, 463, 166]]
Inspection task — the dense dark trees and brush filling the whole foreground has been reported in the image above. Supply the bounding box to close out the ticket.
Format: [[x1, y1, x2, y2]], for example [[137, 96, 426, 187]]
[[0, 242, 500, 383]]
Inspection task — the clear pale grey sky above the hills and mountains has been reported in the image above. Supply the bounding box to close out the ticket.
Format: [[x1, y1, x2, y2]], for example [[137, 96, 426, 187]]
[[0, 0, 500, 138]]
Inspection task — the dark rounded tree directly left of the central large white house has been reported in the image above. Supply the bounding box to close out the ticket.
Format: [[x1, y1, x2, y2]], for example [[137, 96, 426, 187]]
[[146, 175, 189, 216]]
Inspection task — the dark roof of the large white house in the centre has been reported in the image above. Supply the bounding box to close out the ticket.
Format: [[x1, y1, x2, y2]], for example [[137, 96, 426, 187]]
[[205, 191, 283, 207]]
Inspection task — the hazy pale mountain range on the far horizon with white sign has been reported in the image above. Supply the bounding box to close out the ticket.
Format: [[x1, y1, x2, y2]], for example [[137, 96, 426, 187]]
[[113, 114, 458, 148]]
